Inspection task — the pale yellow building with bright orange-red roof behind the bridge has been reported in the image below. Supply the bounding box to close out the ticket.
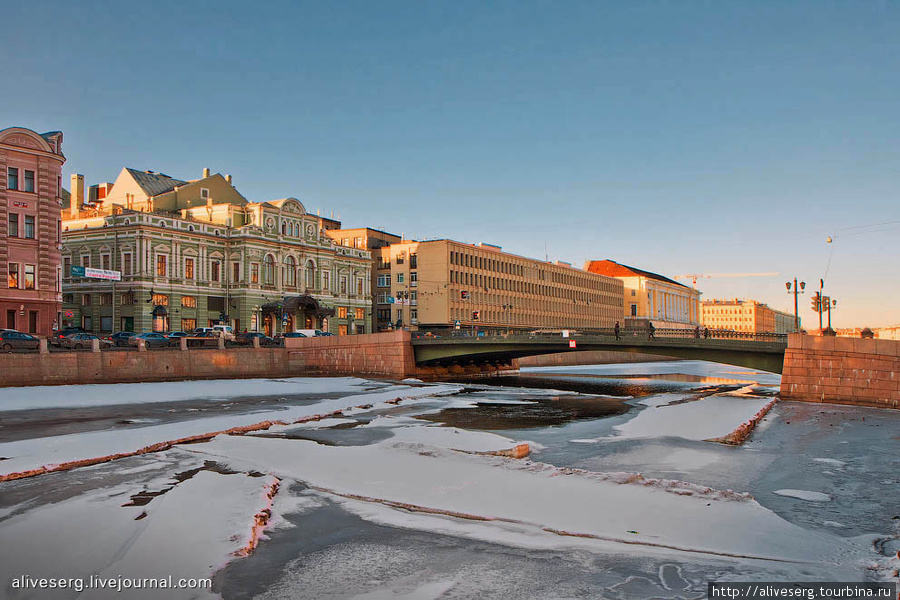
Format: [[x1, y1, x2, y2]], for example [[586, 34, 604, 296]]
[[584, 260, 700, 329]]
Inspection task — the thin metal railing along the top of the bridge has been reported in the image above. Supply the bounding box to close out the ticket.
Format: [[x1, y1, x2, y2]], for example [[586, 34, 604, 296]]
[[412, 328, 787, 344]]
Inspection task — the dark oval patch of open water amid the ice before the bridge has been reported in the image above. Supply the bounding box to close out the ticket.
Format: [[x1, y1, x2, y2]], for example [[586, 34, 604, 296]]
[[418, 395, 631, 430]]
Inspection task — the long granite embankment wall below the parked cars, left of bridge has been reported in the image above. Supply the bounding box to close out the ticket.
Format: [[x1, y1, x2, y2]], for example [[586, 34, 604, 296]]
[[0, 331, 510, 387]]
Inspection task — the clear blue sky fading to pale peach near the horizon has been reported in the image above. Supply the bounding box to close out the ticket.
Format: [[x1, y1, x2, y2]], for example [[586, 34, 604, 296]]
[[0, 0, 900, 327]]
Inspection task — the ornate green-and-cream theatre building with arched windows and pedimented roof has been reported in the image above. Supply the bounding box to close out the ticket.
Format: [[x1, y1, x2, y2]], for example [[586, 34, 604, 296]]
[[62, 169, 371, 335]]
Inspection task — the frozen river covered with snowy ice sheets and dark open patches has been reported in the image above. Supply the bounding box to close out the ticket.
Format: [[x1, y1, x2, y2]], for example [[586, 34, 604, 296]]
[[0, 361, 900, 599]]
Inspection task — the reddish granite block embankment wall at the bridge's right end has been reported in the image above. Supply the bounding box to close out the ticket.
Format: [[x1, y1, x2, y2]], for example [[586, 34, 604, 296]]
[[780, 334, 900, 408]]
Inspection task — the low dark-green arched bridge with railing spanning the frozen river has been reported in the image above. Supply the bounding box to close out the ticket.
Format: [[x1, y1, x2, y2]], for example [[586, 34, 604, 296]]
[[411, 329, 787, 373]]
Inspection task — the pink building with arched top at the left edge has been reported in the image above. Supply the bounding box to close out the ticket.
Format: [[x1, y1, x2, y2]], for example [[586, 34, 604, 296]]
[[0, 127, 66, 336]]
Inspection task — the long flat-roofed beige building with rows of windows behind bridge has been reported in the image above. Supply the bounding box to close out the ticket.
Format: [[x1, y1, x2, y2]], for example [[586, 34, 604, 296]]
[[373, 240, 623, 331]]
